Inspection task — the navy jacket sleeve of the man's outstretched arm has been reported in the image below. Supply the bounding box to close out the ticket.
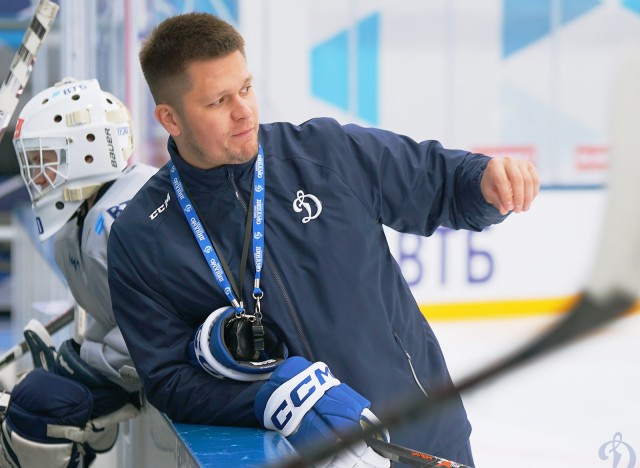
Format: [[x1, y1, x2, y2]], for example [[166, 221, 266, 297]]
[[311, 119, 506, 235]]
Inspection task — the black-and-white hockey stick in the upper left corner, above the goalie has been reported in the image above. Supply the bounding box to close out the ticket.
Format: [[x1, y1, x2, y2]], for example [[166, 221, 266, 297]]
[[0, 0, 60, 140]]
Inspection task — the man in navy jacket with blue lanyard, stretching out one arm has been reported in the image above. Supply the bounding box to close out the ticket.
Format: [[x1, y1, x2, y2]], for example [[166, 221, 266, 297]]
[[109, 13, 538, 466]]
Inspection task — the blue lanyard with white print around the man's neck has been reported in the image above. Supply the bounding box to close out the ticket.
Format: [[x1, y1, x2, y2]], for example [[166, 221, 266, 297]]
[[169, 146, 266, 320]]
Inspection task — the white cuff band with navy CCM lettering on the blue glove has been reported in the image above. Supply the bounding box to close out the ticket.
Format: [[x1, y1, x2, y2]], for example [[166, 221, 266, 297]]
[[263, 362, 340, 437]]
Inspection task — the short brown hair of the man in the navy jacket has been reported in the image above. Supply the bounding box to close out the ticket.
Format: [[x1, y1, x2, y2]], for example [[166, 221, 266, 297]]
[[139, 13, 245, 106]]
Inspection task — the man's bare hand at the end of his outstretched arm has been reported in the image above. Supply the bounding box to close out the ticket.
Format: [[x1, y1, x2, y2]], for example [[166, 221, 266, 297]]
[[480, 157, 540, 215]]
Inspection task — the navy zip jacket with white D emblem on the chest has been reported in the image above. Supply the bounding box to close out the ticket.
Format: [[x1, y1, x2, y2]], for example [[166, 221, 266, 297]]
[[108, 118, 504, 456]]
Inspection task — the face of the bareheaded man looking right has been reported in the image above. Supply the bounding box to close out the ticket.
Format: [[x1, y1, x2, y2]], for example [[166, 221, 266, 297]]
[[172, 51, 258, 169]]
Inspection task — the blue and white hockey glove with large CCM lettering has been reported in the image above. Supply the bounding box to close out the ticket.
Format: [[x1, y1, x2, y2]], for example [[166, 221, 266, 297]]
[[254, 357, 390, 467]]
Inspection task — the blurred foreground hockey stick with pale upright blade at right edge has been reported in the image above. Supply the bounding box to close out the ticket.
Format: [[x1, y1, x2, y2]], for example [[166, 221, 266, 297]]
[[270, 50, 640, 468]]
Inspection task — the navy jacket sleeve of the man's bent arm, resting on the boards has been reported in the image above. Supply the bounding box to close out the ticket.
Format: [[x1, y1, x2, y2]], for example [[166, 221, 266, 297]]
[[108, 222, 262, 427]]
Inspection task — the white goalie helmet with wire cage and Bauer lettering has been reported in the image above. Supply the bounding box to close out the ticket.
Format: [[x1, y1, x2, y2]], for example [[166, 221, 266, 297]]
[[13, 79, 133, 241]]
